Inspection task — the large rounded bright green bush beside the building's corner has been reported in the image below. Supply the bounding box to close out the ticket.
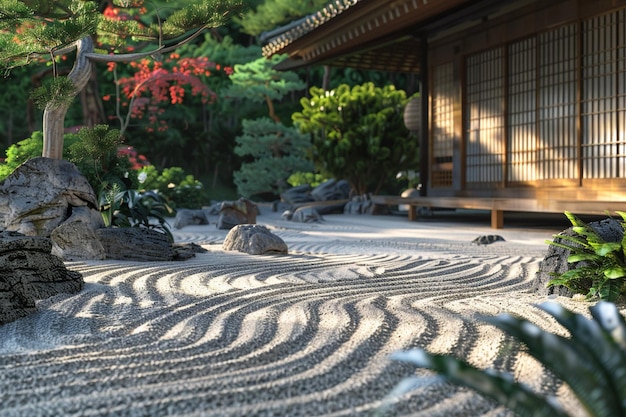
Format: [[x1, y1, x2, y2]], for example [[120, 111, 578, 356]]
[[292, 83, 418, 194]]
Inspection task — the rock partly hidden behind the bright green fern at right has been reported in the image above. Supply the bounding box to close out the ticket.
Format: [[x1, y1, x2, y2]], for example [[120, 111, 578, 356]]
[[532, 218, 624, 297]]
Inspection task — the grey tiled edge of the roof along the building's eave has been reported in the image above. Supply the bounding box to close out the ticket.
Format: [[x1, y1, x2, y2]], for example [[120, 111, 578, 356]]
[[261, 0, 358, 56]]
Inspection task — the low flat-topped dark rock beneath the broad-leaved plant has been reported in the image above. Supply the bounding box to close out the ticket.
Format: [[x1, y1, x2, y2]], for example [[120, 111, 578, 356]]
[[96, 227, 174, 262]]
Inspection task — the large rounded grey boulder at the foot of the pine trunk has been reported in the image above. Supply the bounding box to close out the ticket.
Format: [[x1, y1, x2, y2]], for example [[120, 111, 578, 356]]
[[0, 158, 98, 237]]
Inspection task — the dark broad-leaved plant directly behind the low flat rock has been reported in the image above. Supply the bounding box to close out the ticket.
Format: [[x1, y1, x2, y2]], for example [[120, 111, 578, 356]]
[[100, 184, 174, 242]]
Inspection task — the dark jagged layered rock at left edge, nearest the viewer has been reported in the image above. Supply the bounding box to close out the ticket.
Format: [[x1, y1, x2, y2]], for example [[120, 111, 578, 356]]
[[0, 231, 84, 324]]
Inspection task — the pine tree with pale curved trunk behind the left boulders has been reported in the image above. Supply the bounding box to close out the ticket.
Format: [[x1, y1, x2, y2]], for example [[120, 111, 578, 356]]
[[0, 0, 242, 159]]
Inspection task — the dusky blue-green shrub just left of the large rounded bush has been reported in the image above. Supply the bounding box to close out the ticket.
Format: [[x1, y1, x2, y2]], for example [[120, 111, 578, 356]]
[[234, 118, 312, 197]]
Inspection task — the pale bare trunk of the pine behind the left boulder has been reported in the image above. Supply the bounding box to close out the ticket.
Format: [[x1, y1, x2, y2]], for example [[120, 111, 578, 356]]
[[42, 37, 93, 159]]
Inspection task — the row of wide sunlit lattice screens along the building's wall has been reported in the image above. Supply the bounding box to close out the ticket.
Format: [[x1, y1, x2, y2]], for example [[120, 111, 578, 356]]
[[464, 9, 626, 188]]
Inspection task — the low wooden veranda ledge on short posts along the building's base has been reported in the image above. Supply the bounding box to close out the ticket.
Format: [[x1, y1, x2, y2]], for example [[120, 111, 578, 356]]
[[371, 195, 626, 229]]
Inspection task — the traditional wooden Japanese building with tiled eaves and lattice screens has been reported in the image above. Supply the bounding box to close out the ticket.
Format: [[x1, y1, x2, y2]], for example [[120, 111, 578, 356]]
[[264, 0, 626, 227]]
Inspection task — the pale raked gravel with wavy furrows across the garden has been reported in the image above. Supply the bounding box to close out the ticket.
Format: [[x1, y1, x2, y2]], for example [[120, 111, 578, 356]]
[[0, 214, 586, 417]]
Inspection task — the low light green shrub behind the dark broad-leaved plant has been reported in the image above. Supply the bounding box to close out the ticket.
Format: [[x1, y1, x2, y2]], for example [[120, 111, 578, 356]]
[[139, 165, 208, 209]]
